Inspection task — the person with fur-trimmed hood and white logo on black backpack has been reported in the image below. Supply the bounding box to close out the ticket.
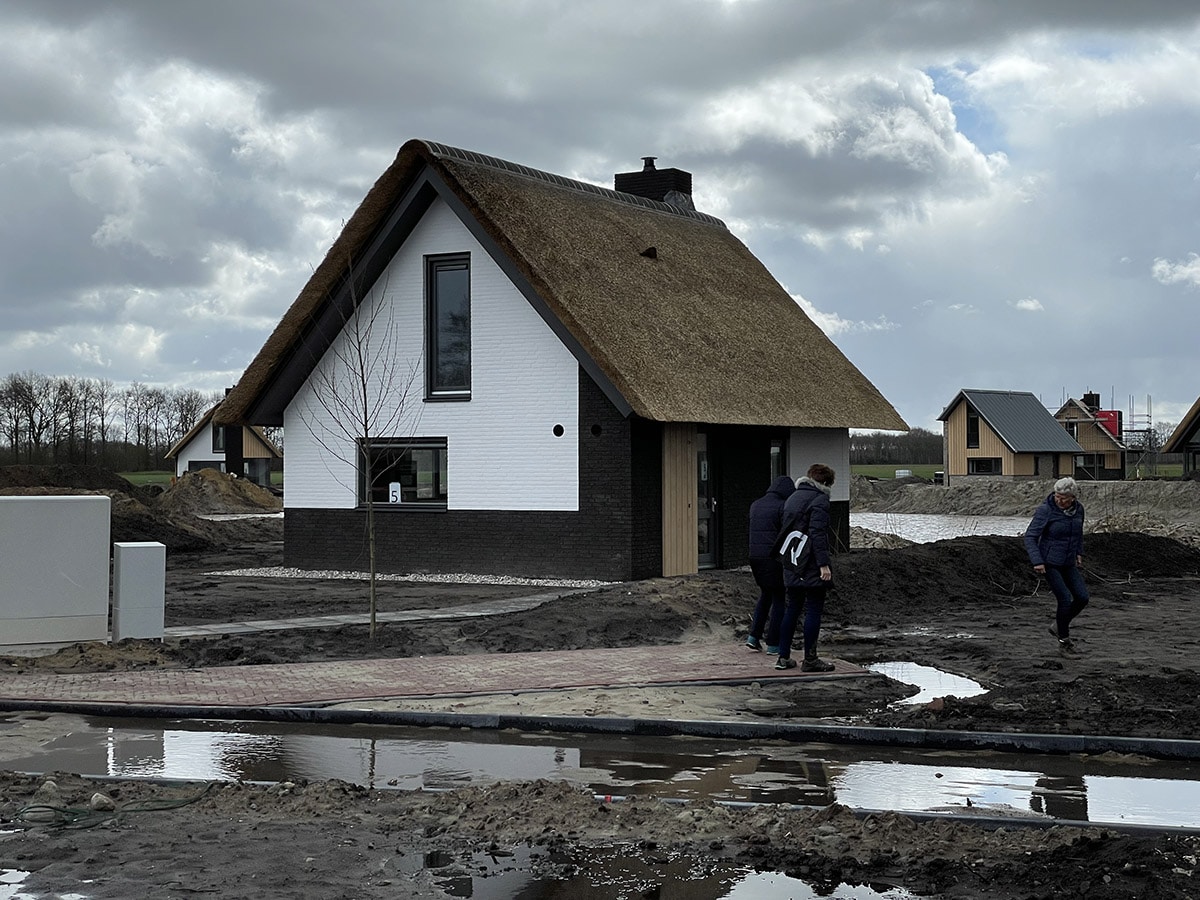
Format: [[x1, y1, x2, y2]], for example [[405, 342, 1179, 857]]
[[775, 462, 835, 672]]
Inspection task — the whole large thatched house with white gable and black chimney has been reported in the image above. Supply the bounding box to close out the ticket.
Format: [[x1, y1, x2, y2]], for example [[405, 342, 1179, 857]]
[[218, 140, 907, 580]]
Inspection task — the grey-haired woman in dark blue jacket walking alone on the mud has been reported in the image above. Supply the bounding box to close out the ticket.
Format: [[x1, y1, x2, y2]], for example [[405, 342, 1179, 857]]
[[1025, 478, 1088, 650]]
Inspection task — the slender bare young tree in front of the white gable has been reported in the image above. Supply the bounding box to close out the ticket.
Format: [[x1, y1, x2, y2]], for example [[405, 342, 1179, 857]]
[[299, 265, 420, 638]]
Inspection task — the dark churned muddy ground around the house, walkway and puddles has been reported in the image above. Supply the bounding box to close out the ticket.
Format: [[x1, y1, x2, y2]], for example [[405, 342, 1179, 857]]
[[0, 468, 1200, 900]]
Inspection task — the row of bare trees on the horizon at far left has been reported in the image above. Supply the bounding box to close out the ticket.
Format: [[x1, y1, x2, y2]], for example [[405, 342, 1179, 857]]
[[0, 372, 223, 472]]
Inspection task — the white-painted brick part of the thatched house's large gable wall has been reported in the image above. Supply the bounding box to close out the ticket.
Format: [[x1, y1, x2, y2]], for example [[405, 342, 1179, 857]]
[[284, 200, 580, 518]]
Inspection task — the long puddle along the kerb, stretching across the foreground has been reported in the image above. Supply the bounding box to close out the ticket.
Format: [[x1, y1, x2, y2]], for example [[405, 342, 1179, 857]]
[[5, 719, 1200, 828]]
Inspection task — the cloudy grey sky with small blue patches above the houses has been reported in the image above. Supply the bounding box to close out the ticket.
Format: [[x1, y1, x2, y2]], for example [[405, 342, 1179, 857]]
[[0, 0, 1200, 430]]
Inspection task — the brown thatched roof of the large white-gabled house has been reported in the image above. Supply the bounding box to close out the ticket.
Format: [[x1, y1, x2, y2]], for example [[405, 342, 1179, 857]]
[[218, 140, 907, 430]]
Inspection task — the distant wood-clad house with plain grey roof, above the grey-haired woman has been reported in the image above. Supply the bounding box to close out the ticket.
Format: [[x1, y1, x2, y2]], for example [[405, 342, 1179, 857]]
[[938, 389, 1084, 484]]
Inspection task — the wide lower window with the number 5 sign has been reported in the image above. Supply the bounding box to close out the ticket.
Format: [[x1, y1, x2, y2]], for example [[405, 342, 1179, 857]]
[[359, 438, 448, 509]]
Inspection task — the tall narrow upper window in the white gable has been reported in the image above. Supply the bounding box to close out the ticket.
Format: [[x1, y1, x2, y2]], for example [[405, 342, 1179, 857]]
[[425, 253, 470, 400]]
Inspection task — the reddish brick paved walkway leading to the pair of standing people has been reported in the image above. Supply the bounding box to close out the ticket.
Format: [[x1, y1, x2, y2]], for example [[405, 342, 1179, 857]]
[[0, 643, 865, 707]]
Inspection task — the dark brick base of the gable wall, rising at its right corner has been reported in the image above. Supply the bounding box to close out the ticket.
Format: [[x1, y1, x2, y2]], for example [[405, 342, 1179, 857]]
[[283, 371, 661, 581]]
